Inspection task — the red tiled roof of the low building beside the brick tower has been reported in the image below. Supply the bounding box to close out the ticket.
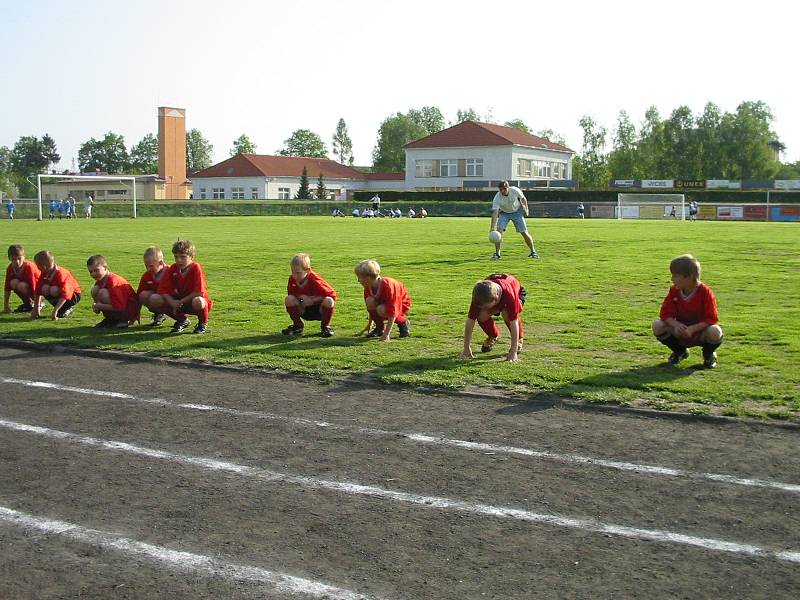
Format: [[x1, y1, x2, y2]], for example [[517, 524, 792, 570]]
[[192, 154, 374, 180]]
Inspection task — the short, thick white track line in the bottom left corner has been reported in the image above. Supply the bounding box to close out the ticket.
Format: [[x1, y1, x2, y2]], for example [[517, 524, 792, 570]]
[[0, 506, 380, 600]]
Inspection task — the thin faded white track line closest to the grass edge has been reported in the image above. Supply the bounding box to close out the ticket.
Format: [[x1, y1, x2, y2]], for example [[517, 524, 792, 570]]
[[0, 377, 800, 494]]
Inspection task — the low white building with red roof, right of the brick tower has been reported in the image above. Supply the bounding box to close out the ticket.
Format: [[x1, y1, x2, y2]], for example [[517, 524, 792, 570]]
[[192, 154, 405, 200]]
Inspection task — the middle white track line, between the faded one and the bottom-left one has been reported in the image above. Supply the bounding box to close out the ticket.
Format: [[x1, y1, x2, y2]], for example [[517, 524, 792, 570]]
[[0, 419, 800, 563]]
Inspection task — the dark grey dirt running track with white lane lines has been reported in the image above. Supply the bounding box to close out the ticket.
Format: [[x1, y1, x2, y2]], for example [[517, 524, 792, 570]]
[[0, 348, 800, 600]]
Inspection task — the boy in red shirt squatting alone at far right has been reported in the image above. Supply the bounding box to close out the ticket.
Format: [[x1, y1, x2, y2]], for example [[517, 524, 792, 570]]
[[653, 254, 722, 369]]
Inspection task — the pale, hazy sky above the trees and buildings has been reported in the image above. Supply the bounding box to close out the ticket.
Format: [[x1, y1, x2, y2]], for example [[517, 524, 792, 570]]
[[0, 0, 800, 169]]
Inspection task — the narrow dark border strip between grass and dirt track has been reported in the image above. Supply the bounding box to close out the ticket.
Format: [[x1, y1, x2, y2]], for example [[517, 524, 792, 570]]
[[0, 337, 800, 431]]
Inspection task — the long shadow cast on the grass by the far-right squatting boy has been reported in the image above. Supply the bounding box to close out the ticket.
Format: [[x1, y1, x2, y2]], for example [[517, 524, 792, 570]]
[[496, 364, 703, 415]]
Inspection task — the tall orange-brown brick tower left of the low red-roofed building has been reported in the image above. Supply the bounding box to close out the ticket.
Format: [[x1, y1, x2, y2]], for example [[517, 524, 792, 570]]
[[158, 106, 189, 200]]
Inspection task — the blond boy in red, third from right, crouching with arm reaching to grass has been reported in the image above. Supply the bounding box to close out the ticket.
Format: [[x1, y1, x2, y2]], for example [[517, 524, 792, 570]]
[[355, 260, 411, 342]]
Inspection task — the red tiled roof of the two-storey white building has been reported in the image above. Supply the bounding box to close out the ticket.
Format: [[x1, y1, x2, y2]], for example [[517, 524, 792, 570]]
[[403, 121, 572, 152]]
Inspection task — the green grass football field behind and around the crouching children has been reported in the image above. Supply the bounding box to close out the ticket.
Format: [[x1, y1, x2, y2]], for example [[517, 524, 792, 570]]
[[0, 217, 800, 420]]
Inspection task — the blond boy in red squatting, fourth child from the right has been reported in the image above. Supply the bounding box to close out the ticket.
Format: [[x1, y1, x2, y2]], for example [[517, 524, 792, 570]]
[[281, 254, 336, 337]]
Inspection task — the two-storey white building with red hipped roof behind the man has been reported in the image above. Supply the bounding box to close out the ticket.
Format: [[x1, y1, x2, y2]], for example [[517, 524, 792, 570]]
[[403, 121, 574, 190]]
